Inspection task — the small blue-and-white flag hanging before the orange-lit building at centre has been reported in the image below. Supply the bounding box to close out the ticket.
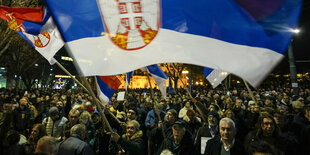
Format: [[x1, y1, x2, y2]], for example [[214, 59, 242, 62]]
[[146, 64, 168, 97]]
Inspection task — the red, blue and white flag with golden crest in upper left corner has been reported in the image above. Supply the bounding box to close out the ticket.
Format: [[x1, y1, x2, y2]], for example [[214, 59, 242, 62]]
[[0, 6, 64, 64]]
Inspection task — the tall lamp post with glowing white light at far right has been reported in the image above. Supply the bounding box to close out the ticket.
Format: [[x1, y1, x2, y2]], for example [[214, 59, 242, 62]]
[[288, 29, 300, 96]]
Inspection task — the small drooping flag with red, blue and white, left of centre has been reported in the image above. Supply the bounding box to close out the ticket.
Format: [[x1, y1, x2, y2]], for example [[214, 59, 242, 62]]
[[96, 76, 121, 103]]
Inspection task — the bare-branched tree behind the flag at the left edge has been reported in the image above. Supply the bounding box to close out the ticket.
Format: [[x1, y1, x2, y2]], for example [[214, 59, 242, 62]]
[[0, 0, 44, 88]]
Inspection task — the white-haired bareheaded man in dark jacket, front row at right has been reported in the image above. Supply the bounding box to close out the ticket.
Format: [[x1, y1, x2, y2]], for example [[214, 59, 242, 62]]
[[204, 117, 244, 155]]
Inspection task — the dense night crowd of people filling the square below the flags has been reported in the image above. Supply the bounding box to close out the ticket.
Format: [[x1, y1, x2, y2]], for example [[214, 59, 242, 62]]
[[0, 78, 310, 155]]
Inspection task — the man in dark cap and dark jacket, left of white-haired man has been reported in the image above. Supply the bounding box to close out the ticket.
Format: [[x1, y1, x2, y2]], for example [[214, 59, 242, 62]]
[[157, 120, 198, 155]]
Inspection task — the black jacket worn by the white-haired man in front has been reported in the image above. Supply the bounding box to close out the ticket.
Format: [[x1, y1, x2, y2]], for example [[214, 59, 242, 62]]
[[204, 136, 245, 155]]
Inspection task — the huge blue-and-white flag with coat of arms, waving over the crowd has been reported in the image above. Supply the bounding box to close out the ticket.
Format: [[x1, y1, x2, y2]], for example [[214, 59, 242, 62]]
[[46, 0, 302, 86]]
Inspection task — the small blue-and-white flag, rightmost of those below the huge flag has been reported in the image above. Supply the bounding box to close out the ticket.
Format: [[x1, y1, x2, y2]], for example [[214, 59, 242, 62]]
[[203, 67, 229, 88]]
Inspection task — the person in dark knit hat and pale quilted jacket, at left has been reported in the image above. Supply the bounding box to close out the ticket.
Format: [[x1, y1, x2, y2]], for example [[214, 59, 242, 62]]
[[42, 107, 68, 140]]
